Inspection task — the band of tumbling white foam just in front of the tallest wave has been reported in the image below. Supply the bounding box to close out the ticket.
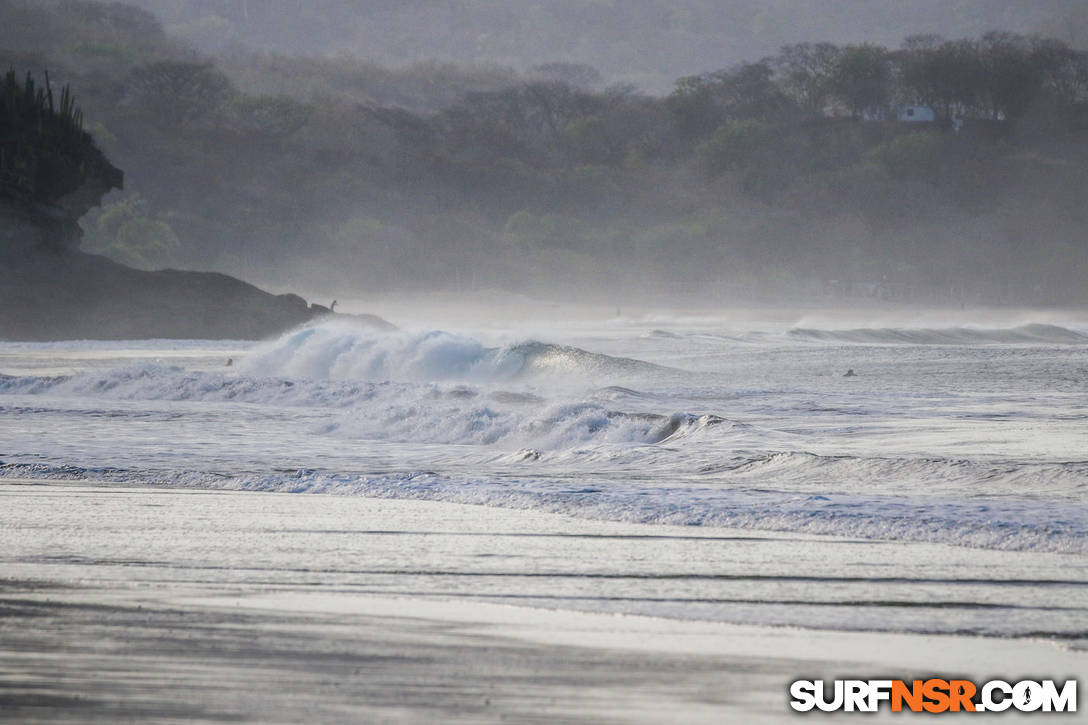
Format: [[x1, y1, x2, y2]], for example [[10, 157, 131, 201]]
[[0, 364, 721, 451]]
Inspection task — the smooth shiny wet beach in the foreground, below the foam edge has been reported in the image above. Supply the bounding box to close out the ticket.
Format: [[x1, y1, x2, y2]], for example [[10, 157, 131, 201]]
[[0, 479, 1088, 723]]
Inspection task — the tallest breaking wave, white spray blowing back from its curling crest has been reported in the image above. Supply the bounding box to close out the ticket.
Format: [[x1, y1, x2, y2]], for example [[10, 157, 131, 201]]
[[240, 322, 662, 382]]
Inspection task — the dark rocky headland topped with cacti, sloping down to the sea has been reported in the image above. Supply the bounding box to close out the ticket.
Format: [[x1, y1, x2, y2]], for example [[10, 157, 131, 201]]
[[0, 72, 374, 341]]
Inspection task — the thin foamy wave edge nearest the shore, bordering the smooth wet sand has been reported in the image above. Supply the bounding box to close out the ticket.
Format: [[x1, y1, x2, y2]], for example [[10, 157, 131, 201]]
[[0, 464, 1088, 554]]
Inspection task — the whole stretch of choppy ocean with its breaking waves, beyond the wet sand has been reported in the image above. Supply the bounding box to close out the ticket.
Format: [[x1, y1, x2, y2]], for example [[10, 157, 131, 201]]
[[0, 316, 1088, 636]]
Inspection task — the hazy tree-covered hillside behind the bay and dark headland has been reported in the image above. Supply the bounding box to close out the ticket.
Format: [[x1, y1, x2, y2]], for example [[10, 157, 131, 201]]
[[0, 0, 1088, 303]]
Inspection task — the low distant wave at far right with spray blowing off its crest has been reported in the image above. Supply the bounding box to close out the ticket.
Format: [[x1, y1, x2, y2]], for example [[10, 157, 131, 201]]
[[788, 322, 1088, 345]]
